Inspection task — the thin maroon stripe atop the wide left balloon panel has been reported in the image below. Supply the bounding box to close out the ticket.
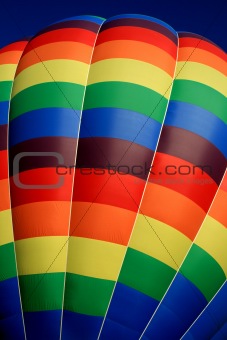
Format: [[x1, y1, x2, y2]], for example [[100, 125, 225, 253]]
[[36, 20, 100, 37]]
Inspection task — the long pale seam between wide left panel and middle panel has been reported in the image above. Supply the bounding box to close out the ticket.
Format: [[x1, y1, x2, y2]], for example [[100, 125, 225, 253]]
[[59, 20, 105, 340]]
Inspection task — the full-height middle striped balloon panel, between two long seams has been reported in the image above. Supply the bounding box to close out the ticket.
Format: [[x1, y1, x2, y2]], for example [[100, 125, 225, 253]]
[[62, 16, 177, 339]]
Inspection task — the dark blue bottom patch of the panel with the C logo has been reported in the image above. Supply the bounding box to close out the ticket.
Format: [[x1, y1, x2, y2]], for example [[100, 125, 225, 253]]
[[23, 310, 62, 340]]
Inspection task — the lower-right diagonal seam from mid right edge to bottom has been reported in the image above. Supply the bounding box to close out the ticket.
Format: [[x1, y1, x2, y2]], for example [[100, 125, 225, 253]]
[[139, 170, 227, 340]]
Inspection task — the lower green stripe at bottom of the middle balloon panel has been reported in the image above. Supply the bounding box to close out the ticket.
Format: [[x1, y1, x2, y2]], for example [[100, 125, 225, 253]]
[[64, 273, 114, 316]]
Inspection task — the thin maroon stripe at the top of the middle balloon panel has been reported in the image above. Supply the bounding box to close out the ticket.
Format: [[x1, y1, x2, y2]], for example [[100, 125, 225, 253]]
[[100, 18, 178, 45]]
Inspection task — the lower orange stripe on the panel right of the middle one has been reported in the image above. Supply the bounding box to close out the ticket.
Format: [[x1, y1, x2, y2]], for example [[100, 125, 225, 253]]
[[140, 183, 206, 240]]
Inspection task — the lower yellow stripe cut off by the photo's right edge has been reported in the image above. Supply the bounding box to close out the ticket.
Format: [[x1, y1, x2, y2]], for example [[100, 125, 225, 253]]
[[195, 216, 227, 276]]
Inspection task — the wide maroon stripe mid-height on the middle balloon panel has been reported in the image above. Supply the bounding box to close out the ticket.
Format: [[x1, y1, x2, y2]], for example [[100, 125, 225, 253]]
[[76, 137, 154, 180]]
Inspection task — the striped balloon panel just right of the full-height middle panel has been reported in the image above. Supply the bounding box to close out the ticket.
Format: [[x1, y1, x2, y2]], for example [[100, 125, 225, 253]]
[[97, 35, 227, 339]]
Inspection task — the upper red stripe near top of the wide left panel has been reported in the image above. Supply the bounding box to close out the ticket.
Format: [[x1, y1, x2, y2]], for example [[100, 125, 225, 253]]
[[23, 28, 96, 55]]
